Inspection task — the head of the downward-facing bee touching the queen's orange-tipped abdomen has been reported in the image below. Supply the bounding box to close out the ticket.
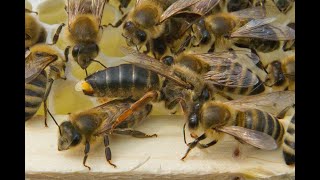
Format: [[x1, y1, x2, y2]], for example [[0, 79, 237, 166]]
[[72, 43, 99, 69]]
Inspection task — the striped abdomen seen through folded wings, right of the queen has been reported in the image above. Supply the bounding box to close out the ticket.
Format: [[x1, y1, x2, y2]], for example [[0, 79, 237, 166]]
[[211, 63, 265, 95]]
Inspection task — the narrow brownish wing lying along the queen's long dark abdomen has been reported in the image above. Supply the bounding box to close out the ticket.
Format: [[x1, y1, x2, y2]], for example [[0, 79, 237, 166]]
[[120, 47, 191, 89]]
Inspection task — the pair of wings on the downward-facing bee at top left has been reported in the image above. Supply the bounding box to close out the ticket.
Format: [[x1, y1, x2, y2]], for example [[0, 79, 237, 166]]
[[68, 0, 106, 26]]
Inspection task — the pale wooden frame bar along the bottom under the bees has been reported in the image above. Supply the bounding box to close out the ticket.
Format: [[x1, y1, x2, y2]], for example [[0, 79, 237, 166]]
[[25, 115, 295, 180]]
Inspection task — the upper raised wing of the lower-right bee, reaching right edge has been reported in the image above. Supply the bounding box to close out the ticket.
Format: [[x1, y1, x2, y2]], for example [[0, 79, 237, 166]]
[[225, 91, 295, 116]]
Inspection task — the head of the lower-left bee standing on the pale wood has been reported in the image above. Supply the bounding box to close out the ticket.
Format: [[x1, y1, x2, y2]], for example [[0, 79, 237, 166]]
[[58, 121, 82, 151]]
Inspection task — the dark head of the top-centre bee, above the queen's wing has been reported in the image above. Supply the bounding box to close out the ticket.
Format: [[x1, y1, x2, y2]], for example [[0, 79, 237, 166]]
[[123, 21, 147, 46]]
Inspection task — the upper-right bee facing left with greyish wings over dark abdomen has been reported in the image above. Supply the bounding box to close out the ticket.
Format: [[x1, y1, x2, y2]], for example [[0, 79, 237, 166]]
[[185, 6, 295, 52]]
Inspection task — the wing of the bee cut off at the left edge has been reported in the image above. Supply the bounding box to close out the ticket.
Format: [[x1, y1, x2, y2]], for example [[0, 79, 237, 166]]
[[25, 53, 58, 83]]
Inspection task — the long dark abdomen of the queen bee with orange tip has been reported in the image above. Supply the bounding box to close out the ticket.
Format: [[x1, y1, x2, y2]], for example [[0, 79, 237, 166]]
[[84, 64, 161, 99]]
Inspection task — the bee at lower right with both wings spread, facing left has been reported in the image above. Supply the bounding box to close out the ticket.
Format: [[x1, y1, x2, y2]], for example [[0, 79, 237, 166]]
[[181, 91, 295, 165]]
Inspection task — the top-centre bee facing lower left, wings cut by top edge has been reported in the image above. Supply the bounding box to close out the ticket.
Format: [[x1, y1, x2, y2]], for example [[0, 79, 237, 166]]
[[105, 0, 218, 58]]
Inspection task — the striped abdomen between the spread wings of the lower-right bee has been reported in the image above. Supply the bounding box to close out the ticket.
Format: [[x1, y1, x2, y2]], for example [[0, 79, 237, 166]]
[[236, 109, 284, 146]]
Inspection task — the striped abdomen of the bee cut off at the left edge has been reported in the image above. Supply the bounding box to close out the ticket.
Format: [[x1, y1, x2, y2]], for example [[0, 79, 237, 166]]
[[25, 71, 47, 121]]
